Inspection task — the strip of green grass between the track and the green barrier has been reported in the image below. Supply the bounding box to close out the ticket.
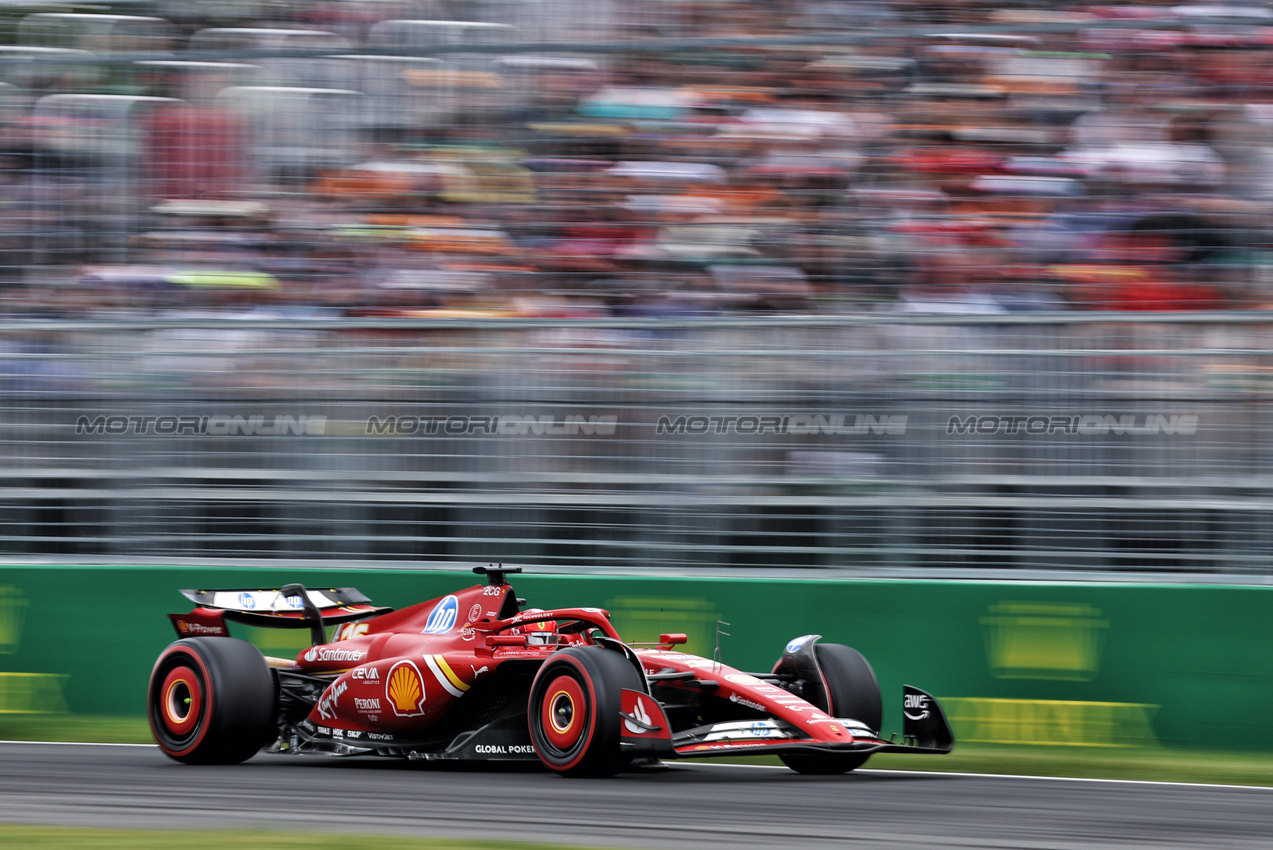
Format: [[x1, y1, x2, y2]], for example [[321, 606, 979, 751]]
[[9, 714, 1273, 788]]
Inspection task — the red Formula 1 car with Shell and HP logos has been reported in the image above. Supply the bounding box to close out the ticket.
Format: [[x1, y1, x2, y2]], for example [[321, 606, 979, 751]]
[[148, 568, 955, 776]]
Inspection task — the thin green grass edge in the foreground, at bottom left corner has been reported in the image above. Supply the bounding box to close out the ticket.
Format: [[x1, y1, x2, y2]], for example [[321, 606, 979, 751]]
[[0, 825, 595, 850]]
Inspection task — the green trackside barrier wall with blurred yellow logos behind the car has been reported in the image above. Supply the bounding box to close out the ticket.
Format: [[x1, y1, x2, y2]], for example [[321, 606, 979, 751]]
[[0, 568, 1273, 751]]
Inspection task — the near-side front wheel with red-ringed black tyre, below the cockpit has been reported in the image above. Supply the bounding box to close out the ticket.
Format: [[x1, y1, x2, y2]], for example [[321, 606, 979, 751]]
[[527, 646, 642, 776]]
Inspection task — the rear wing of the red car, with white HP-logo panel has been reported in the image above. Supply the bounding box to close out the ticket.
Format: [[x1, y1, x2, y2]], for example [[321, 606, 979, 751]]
[[168, 584, 393, 645]]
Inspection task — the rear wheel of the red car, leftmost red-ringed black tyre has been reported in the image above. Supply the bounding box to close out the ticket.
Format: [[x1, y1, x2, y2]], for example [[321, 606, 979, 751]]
[[148, 638, 275, 765]]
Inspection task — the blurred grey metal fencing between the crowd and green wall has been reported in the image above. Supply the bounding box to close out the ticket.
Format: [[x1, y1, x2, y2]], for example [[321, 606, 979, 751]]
[[0, 314, 1273, 579]]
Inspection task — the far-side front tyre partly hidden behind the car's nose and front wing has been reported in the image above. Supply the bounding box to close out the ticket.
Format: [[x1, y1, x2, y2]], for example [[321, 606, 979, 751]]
[[780, 644, 883, 776]]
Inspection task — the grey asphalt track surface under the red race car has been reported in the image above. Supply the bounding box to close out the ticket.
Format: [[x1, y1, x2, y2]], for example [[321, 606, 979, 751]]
[[0, 743, 1273, 850]]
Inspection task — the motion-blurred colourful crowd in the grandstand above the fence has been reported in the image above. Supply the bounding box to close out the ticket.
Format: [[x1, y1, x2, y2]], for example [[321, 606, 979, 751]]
[[0, 0, 1273, 317]]
